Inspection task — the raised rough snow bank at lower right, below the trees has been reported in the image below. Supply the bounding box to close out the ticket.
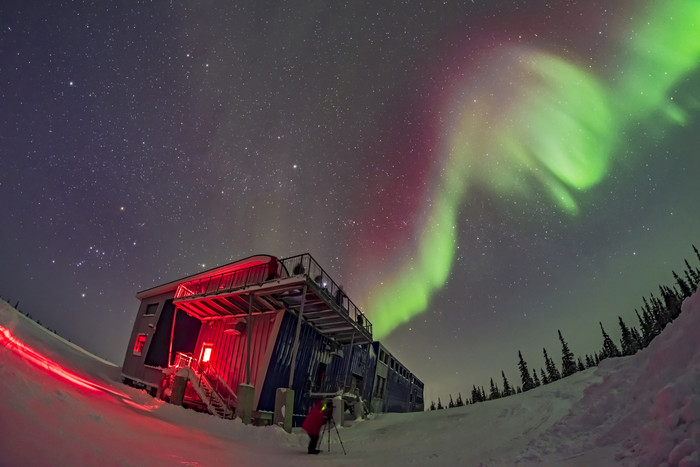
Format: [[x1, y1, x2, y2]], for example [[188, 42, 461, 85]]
[[520, 292, 700, 467]]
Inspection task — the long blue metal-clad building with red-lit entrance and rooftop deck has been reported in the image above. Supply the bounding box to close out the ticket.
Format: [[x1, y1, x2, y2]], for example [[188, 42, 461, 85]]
[[122, 254, 424, 429]]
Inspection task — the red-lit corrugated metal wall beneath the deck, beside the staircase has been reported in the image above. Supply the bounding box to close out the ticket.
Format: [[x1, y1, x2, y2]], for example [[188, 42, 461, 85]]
[[195, 313, 276, 391]]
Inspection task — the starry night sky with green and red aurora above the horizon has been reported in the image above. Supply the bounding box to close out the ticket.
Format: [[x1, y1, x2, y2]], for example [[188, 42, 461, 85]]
[[0, 0, 700, 401]]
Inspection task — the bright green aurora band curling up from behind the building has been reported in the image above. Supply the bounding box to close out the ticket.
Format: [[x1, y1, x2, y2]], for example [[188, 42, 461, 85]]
[[368, 0, 700, 340]]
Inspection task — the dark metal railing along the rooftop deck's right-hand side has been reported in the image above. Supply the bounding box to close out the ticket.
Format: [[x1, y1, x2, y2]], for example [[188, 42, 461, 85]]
[[280, 253, 372, 336]]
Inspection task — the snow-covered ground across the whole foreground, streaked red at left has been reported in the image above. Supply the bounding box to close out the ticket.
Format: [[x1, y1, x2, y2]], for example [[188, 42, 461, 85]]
[[0, 293, 700, 467]]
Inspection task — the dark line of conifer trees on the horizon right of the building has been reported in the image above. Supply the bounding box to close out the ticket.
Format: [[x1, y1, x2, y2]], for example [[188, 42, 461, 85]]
[[430, 245, 700, 410]]
